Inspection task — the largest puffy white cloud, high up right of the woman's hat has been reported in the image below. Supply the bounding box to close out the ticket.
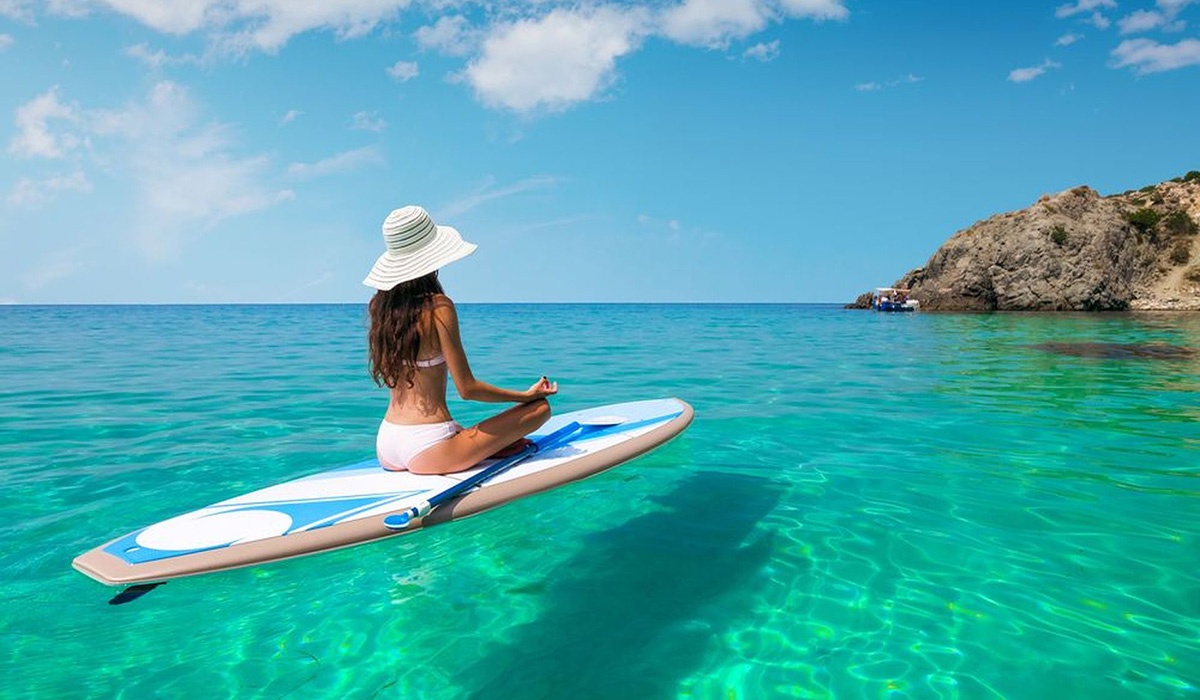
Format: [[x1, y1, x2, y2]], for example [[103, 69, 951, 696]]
[[464, 7, 648, 113]]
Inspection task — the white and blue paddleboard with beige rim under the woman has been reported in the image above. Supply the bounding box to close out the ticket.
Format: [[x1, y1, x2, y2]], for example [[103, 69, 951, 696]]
[[72, 399, 692, 585]]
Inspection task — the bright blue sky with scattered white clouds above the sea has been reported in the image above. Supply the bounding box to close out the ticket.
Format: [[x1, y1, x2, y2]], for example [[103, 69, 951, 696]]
[[0, 0, 1200, 303]]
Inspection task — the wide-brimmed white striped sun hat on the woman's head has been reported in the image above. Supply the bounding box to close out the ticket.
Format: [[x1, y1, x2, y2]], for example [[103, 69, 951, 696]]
[[362, 204, 476, 291]]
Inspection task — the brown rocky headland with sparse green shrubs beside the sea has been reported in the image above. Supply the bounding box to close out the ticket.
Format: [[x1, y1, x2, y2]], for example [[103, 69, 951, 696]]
[[851, 170, 1200, 311]]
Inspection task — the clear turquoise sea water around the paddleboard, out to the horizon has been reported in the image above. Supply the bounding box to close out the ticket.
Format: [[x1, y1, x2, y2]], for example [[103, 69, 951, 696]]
[[0, 305, 1200, 700]]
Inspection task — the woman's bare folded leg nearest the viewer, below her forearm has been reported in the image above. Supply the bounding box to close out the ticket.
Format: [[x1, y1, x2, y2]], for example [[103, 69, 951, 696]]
[[408, 399, 550, 474]]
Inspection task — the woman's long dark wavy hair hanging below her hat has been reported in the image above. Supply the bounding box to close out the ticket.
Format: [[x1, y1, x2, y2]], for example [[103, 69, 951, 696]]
[[367, 270, 444, 389]]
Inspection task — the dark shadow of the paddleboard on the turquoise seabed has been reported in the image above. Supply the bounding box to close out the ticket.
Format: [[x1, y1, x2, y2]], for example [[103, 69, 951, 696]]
[[457, 472, 782, 700]]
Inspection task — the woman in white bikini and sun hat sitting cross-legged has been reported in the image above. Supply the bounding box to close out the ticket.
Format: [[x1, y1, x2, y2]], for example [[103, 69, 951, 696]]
[[362, 207, 558, 474]]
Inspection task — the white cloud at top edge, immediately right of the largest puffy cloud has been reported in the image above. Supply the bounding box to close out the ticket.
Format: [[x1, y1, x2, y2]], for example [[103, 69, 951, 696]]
[[660, 0, 770, 48]]
